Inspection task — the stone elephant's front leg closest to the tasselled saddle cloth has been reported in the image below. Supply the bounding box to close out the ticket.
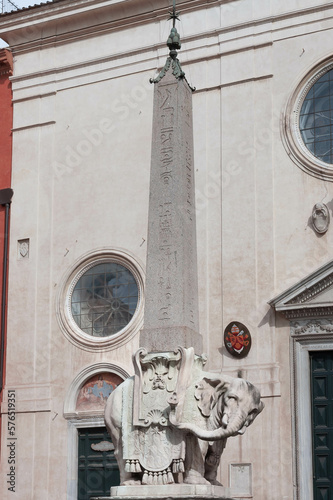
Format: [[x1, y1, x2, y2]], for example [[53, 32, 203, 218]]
[[184, 434, 209, 484]]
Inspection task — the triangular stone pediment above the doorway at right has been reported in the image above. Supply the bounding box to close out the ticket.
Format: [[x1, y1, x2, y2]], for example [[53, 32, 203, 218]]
[[268, 261, 333, 319]]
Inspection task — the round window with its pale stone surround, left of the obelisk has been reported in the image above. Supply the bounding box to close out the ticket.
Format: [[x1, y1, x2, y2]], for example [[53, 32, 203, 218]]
[[57, 248, 144, 351]]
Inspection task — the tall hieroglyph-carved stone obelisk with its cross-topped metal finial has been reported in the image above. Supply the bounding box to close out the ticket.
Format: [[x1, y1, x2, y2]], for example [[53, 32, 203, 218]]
[[140, 4, 202, 354]]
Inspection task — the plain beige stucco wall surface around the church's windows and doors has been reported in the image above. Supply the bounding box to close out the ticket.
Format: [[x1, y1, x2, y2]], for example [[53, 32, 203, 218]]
[[0, 0, 333, 500]]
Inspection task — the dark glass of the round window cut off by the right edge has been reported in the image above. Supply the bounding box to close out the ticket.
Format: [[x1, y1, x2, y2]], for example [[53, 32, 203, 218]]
[[299, 69, 333, 164]]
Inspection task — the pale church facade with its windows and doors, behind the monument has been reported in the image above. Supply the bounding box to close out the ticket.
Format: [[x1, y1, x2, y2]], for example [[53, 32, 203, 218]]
[[0, 0, 333, 500]]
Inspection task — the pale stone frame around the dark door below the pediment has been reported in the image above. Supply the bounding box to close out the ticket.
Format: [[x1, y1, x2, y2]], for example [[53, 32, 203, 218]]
[[291, 326, 333, 500]]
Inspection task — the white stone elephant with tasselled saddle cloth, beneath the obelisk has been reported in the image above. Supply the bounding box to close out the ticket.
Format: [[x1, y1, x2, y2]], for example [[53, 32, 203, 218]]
[[105, 348, 264, 485]]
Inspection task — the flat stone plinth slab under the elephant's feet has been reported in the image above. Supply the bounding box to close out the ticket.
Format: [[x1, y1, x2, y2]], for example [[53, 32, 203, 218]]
[[91, 484, 233, 500]]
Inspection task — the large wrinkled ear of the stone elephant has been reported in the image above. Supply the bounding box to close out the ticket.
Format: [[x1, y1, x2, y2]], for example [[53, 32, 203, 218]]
[[194, 377, 227, 417]]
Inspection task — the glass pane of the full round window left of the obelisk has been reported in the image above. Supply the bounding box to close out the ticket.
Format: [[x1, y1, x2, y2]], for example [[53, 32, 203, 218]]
[[71, 262, 138, 337]]
